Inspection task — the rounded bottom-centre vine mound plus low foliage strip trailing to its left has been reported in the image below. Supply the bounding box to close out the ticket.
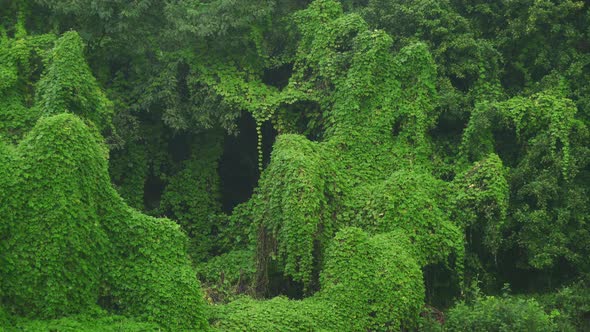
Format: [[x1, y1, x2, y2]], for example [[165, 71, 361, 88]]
[[210, 228, 424, 331]]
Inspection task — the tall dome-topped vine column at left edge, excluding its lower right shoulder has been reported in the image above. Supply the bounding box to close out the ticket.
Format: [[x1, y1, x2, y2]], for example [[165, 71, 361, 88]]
[[2, 115, 108, 318]]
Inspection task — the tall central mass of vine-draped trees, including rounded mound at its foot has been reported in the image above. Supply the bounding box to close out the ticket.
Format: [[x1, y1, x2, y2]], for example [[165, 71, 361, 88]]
[[208, 1, 507, 331]]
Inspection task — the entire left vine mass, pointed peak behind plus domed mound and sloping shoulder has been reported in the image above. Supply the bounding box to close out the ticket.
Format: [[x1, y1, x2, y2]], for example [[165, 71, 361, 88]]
[[0, 27, 207, 330]]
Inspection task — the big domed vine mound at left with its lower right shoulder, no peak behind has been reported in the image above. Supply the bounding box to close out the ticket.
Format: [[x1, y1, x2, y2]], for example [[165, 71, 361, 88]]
[[0, 113, 206, 329]]
